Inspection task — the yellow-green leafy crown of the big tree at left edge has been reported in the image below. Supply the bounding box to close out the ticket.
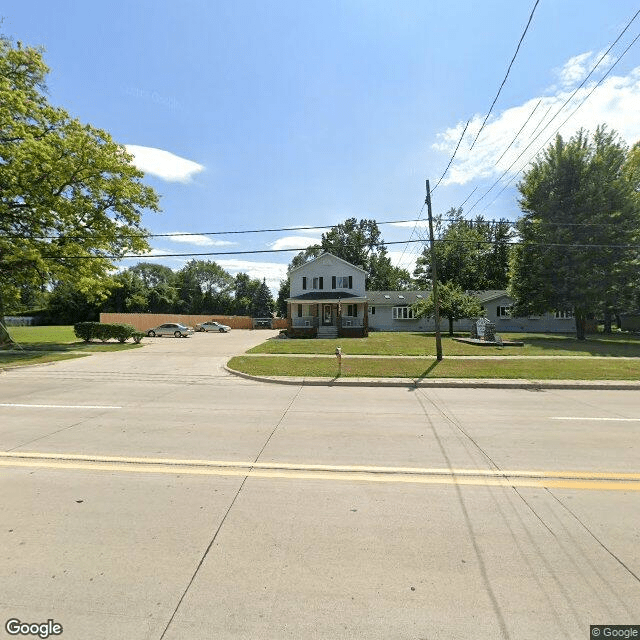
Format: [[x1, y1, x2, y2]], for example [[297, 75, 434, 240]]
[[0, 37, 158, 311]]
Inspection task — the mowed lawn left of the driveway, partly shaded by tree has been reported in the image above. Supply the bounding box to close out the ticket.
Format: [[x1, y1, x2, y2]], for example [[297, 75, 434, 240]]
[[0, 326, 142, 368]]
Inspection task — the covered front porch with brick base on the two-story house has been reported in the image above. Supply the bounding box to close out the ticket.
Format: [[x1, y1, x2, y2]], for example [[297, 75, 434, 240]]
[[287, 297, 369, 338]]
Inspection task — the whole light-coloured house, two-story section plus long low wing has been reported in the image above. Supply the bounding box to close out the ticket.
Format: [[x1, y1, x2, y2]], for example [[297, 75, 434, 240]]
[[287, 253, 575, 338]]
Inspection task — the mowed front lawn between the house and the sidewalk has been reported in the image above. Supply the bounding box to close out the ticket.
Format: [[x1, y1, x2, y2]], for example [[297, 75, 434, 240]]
[[247, 332, 640, 358]]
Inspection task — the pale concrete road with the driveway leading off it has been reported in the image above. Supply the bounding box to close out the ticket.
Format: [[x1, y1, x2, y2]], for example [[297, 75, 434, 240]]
[[0, 331, 640, 640]]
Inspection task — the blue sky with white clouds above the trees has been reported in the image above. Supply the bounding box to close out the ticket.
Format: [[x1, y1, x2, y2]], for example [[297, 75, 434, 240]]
[[5, 0, 640, 290]]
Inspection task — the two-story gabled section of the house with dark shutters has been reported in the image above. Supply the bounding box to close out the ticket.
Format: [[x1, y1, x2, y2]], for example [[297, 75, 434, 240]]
[[287, 253, 368, 338]]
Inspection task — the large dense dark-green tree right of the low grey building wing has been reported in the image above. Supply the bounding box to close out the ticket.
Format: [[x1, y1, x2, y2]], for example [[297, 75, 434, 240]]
[[510, 126, 640, 340]]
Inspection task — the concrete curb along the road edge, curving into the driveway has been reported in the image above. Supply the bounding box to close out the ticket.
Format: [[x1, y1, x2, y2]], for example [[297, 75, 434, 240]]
[[224, 364, 640, 391]]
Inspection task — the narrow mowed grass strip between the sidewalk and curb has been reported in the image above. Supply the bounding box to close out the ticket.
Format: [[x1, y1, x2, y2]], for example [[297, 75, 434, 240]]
[[228, 355, 640, 380]]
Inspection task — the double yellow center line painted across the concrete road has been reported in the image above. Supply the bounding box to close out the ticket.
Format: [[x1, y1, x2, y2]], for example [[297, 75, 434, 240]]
[[0, 452, 640, 491]]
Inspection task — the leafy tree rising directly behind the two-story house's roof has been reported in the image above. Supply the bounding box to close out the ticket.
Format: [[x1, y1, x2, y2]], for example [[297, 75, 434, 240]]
[[289, 218, 412, 291]]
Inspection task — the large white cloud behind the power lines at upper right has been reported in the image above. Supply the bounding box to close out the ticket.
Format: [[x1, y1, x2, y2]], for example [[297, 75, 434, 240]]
[[433, 54, 640, 185]]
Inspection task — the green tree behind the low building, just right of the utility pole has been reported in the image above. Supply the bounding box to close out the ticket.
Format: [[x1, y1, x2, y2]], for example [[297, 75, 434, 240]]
[[413, 208, 514, 291]]
